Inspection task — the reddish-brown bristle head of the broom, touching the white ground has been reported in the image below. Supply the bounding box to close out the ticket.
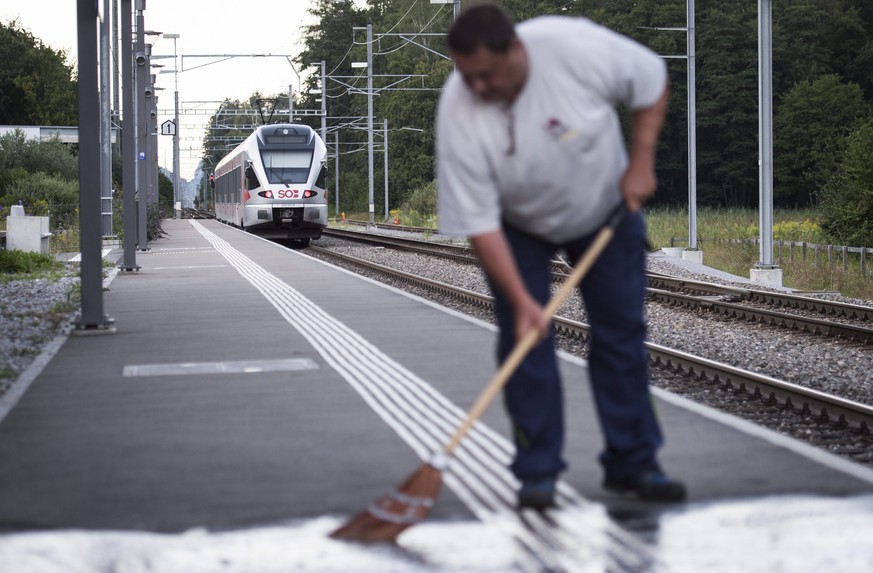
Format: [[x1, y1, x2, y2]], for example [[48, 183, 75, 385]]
[[330, 463, 443, 543]]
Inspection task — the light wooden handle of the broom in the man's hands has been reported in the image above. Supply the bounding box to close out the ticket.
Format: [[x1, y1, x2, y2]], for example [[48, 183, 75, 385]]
[[444, 203, 627, 456]]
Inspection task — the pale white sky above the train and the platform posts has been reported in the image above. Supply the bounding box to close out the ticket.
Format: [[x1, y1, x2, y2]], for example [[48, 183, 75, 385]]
[[0, 0, 334, 179]]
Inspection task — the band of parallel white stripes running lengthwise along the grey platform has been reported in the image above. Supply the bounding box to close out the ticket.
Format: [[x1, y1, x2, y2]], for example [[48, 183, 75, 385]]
[[191, 221, 654, 571]]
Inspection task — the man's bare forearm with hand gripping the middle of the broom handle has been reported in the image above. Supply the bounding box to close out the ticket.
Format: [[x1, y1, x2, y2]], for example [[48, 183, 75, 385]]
[[470, 231, 551, 340]]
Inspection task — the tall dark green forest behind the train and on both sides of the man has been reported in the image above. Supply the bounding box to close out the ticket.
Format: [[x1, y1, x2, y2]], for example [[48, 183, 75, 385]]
[[194, 0, 873, 219]]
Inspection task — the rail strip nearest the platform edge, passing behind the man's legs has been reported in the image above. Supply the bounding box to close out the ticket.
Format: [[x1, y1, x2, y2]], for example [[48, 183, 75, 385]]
[[310, 242, 873, 431]]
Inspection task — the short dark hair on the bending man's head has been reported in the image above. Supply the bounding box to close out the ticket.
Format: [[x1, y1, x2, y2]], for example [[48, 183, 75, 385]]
[[448, 4, 515, 56]]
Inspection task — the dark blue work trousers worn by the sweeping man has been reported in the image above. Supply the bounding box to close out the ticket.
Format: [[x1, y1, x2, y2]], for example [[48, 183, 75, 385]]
[[491, 213, 663, 480]]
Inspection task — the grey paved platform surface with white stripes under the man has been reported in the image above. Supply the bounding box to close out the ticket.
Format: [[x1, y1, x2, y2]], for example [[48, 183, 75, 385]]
[[0, 220, 873, 571]]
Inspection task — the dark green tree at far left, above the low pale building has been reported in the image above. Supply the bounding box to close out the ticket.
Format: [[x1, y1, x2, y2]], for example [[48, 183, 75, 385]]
[[0, 21, 78, 125]]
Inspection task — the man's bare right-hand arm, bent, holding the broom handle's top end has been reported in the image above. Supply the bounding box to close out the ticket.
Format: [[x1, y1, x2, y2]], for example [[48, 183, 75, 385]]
[[621, 84, 668, 212]]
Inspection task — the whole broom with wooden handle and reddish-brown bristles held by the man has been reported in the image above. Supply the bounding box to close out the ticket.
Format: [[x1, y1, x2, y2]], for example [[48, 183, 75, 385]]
[[330, 203, 627, 542]]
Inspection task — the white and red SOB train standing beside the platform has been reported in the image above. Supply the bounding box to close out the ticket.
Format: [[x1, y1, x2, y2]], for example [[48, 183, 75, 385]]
[[211, 123, 328, 246]]
